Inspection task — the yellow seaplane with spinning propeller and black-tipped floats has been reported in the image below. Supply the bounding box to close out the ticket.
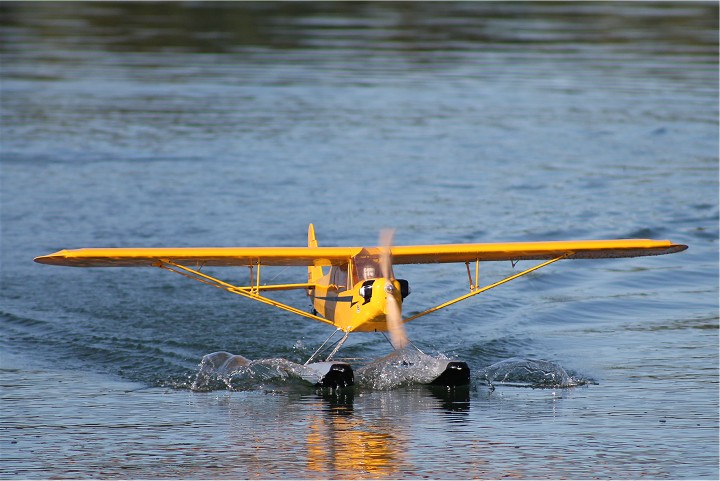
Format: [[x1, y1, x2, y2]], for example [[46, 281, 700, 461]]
[[35, 224, 687, 388]]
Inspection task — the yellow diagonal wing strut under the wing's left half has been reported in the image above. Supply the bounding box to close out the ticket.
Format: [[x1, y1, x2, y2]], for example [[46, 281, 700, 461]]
[[154, 260, 333, 325]]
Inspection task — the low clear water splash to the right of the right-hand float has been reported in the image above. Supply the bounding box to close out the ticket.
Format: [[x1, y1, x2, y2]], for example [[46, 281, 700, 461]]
[[480, 357, 592, 390]]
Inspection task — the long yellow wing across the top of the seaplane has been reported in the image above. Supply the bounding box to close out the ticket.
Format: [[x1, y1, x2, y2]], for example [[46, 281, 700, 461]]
[[35, 239, 687, 267]]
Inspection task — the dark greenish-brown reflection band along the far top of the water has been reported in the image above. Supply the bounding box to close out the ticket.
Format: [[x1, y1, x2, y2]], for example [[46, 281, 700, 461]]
[[0, 2, 718, 58]]
